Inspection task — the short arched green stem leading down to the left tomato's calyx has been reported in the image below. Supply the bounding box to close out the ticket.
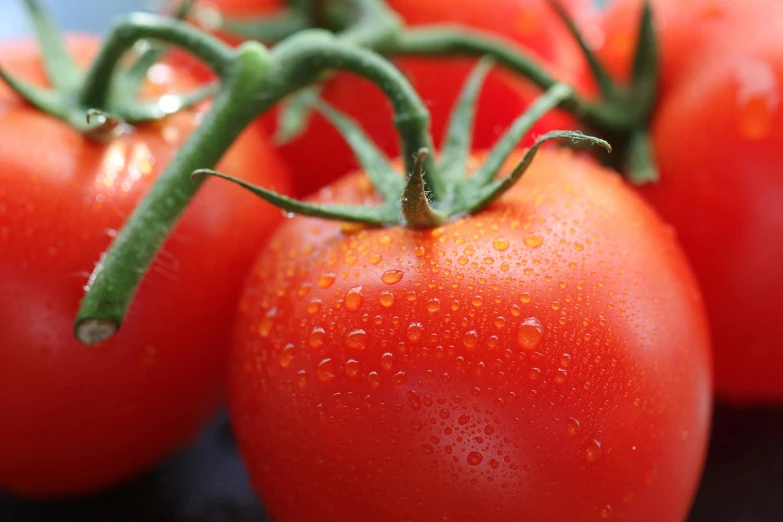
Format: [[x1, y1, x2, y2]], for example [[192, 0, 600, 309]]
[[79, 13, 234, 107]]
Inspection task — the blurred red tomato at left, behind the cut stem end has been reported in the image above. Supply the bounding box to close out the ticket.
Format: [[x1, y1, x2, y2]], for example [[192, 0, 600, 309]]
[[0, 37, 288, 497]]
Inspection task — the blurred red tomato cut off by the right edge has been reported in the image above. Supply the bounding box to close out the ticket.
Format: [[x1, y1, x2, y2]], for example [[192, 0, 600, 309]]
[[604, 0, 783, 398]]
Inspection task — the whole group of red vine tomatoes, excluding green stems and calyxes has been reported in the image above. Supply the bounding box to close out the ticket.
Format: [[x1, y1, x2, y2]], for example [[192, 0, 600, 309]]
[[0, 0, 783, 522]]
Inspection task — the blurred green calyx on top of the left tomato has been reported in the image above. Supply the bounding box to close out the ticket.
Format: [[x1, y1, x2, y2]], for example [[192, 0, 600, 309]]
[[0, 0, 217, 142]]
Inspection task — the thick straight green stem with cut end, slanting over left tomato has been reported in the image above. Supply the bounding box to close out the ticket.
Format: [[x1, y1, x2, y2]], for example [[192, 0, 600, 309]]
[[74, 43, 270, 344]]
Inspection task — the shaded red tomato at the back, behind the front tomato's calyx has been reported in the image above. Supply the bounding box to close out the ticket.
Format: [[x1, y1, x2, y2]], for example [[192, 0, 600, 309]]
[[176, 0, 592, 195]]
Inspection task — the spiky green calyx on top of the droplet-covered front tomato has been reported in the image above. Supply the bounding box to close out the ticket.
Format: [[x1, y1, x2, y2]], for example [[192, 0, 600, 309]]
[[198, 59, 611, 229]]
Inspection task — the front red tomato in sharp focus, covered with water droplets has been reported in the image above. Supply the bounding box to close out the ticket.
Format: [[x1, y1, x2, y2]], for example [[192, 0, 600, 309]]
[[230, 147, 711, 522]]
